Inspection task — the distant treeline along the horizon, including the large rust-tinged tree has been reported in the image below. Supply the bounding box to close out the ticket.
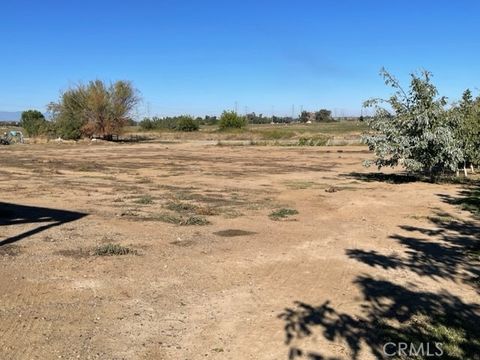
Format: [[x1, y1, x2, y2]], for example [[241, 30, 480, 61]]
[[15, 80, 364, 140]]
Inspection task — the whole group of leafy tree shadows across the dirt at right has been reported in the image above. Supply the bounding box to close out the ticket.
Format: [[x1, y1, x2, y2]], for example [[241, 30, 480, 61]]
[[279, 187, 480, 360]]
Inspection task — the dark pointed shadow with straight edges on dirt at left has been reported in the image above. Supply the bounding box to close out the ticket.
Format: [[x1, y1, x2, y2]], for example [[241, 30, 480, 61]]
[[0, 202, 87, 246]]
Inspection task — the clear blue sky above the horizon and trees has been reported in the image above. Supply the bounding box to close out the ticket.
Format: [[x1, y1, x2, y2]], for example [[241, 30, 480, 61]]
[[0, 0, 480, 116]]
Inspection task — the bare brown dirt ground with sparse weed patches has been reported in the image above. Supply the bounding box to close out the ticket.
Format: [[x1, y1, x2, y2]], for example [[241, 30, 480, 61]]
[[0, 143, 480, 359]]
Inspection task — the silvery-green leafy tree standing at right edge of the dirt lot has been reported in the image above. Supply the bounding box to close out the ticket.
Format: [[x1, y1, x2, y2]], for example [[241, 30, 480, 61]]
[[364, 69, 463, 180]]
